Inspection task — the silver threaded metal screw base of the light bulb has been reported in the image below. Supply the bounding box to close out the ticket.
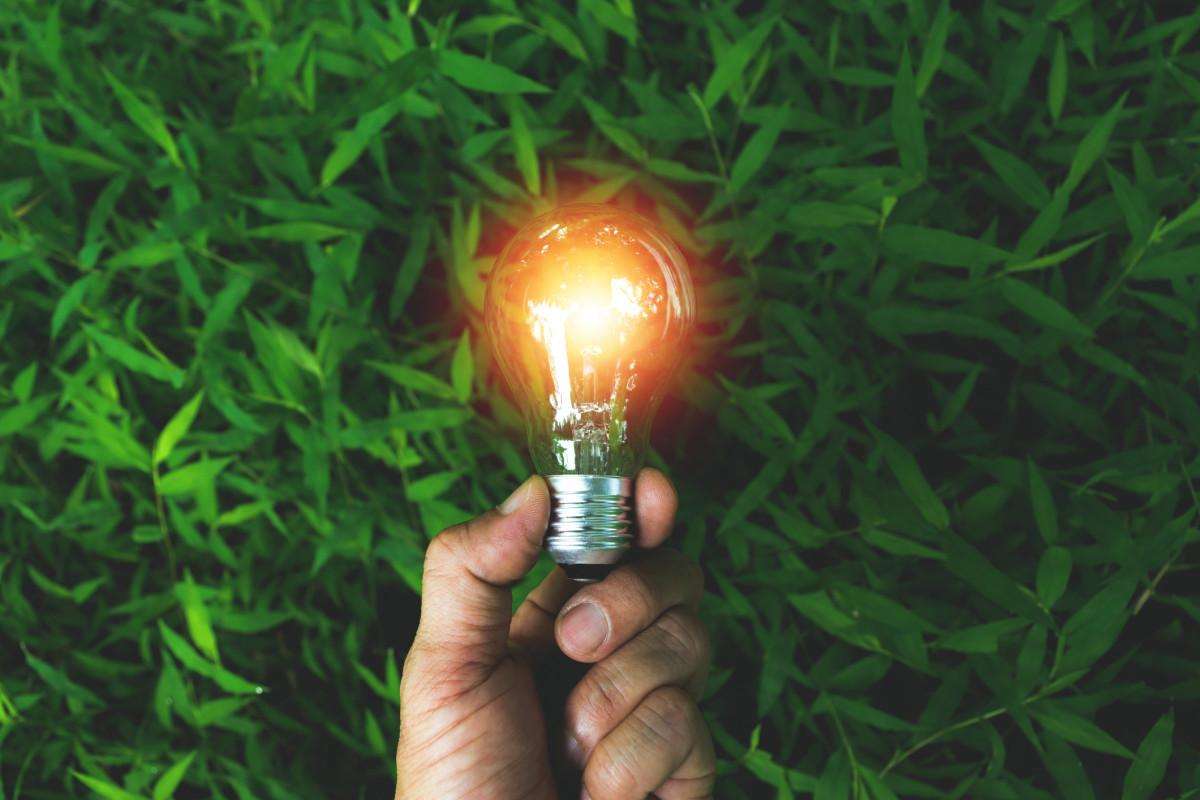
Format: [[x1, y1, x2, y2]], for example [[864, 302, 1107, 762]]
[[545, 475, 634, 582]]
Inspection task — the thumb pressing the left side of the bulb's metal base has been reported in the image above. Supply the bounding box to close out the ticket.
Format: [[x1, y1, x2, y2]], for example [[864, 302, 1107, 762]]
[[414, 475, 550, 669]]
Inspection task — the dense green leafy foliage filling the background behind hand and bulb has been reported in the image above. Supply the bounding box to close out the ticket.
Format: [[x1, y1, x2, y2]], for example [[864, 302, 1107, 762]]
[[0, 0, 1200, 800]]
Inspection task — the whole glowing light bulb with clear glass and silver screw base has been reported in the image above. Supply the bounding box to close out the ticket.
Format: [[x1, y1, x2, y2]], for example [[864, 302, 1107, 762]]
[[484, 204, 695, 581]]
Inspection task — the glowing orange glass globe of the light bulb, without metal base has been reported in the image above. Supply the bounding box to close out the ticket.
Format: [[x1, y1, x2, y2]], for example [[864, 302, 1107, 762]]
[[486, 205, 694, 471]]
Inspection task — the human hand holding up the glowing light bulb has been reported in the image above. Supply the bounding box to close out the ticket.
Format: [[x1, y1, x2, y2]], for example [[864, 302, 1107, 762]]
[[396, 469, 715, 800]]
